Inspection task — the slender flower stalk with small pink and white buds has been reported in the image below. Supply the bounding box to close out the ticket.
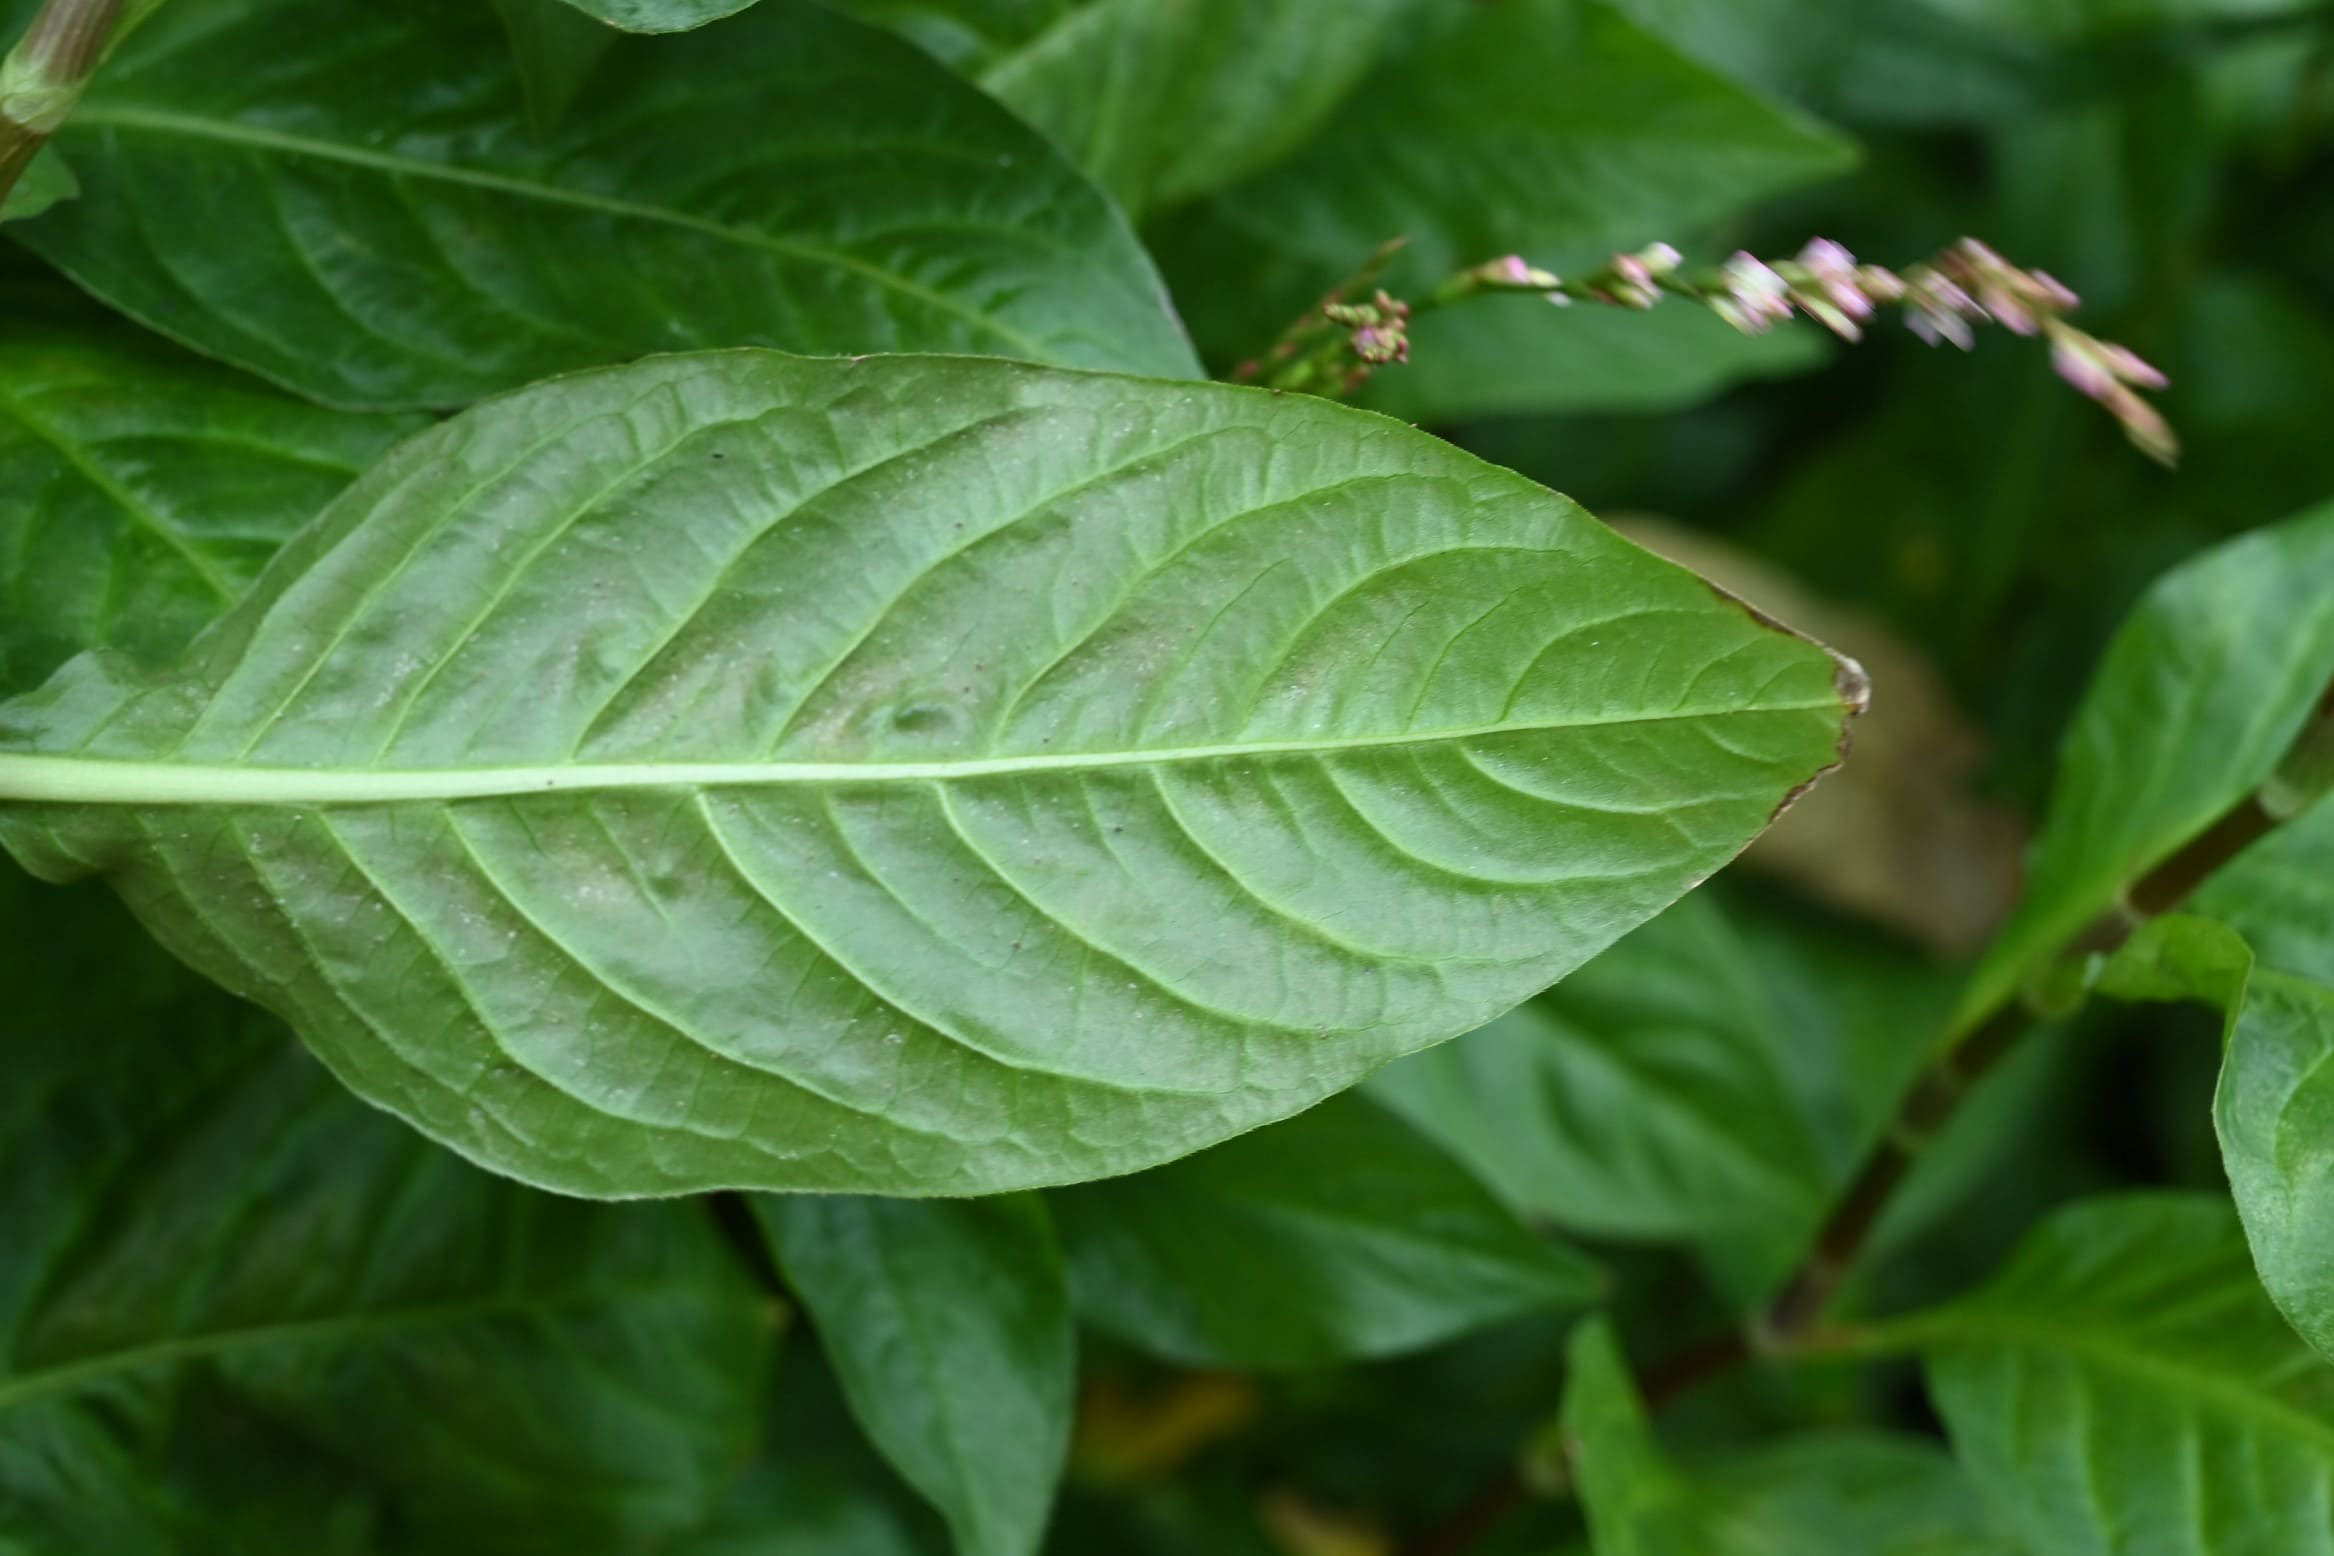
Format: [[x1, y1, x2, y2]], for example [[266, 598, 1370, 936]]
[[1235, 238, 2180, 464]]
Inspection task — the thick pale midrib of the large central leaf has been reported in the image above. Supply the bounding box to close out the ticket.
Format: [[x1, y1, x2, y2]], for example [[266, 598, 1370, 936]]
[[0, 698, 1842, 805]]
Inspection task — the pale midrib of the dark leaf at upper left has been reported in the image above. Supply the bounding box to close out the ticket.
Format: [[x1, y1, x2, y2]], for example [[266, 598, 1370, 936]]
[[70, 105, 1050, 362]]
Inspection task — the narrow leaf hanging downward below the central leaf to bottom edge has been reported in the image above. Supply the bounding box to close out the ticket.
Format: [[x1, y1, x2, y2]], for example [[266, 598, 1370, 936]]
[[754, 1194, 1078, 1556]]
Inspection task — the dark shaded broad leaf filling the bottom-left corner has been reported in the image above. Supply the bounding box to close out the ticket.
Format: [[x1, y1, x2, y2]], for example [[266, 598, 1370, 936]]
[[0, 863, 775, 1556]]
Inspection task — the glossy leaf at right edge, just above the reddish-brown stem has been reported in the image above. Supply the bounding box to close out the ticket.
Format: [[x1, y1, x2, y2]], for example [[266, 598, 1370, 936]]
[[1963, 504, 2334, 1019]]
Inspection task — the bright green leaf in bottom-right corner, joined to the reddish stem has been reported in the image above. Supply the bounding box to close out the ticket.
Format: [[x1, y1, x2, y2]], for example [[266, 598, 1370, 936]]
[[1895, 1194, 2334, 1556]]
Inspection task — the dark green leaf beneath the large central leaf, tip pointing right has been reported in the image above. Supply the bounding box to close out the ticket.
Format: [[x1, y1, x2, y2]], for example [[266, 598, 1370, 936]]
[[1053, 1096, 1603, 1367]]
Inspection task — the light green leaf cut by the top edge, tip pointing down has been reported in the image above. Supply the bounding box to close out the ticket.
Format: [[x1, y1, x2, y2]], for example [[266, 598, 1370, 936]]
[[843, 0, 1424, 212]]
